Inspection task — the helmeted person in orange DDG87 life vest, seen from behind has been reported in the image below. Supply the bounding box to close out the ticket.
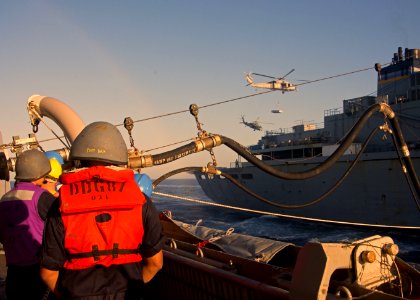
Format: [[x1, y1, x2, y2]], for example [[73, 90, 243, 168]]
[[41, 122, 163, 300]]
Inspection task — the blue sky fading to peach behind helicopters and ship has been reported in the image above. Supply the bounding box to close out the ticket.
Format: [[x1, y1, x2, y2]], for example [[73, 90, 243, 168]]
[[0, 0, 420, 177]]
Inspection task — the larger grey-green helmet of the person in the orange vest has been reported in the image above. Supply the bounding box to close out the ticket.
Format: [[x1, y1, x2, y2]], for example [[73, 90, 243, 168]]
[[70, 122, 128, 165]]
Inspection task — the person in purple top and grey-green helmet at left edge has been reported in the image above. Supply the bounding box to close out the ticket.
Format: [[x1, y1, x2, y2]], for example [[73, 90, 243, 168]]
[[0, 149, 56, 300]]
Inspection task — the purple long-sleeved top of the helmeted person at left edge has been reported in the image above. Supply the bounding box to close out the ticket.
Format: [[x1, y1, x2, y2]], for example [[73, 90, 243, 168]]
[[0, 182, 55, 266]]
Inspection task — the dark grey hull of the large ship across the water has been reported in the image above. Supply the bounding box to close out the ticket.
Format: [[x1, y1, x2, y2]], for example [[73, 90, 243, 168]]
[[196, 151, 420, 229]]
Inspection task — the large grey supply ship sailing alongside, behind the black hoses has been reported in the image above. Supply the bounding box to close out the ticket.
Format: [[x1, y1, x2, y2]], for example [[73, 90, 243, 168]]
[[195, 47, 420, 229]]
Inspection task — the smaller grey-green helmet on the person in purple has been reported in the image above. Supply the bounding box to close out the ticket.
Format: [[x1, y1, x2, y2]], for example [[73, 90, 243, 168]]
[[15, 149, 51, 181]]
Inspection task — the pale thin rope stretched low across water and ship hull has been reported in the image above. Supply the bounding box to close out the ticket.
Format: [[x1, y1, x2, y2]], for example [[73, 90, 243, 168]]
[[153, 191, 419, 229]]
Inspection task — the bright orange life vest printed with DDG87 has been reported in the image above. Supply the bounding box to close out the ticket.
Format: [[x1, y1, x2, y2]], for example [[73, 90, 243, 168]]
[[60, 166, 146, 270]]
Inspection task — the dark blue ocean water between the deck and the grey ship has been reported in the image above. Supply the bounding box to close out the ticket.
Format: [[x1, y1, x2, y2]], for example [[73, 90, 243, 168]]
[[152, 179, 420, 269]]
